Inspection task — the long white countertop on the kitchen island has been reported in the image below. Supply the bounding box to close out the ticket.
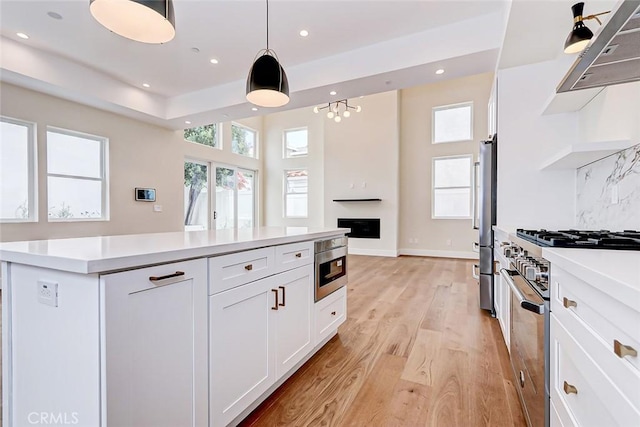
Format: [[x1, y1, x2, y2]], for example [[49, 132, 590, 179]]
[[0, 227, 349, 274]]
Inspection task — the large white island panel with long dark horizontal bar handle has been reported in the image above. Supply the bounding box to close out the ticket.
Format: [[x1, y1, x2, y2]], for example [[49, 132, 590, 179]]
[[101, 259, 207, 427]]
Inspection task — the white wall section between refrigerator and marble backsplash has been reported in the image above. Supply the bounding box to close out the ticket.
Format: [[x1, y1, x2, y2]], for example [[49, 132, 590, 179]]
[[497, 58, 578, 230]]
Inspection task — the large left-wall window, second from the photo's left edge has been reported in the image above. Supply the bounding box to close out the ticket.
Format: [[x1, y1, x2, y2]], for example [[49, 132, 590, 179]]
[[47, 128, 109, 221]]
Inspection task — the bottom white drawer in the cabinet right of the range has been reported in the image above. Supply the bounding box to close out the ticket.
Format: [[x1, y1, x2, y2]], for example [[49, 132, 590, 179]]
[[550, 313, 640, 426]]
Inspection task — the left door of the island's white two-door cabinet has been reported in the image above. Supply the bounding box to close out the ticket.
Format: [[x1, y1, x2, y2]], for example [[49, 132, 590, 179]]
[[209, 277, 277, 426]]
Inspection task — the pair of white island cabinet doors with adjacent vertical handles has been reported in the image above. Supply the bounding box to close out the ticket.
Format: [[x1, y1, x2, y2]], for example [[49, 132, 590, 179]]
[[209, 251, 315, 426]]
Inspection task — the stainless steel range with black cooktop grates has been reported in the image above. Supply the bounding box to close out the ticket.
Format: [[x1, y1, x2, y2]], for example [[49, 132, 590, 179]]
[[500, 229, 640, 427]]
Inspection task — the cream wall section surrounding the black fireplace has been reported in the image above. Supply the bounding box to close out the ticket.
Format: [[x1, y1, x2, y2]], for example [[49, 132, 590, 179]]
[[324, 91, 400, 256]]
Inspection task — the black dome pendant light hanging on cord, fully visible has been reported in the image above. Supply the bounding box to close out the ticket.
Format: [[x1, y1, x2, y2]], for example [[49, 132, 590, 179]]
[[247, 0, 289, 107]]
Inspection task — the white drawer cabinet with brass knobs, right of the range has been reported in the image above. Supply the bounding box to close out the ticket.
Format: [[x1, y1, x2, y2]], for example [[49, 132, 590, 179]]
[[550, 264, 640, 427]]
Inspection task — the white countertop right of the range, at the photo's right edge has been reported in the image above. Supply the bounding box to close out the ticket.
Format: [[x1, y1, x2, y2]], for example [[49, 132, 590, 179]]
[[542, 248, 640, 311]]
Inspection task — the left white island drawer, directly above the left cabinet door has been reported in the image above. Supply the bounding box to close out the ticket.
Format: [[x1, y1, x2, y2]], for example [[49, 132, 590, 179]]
[[209, 247, 275, 295]]
